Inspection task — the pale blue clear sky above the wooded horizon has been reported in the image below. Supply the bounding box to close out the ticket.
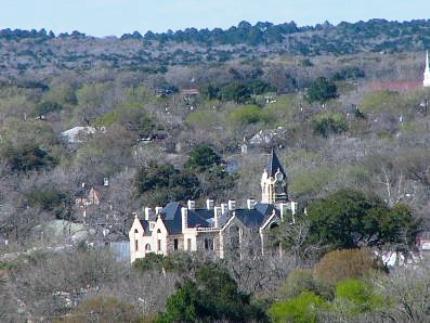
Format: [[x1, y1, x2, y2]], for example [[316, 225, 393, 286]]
[[0, 0, 430, 37]]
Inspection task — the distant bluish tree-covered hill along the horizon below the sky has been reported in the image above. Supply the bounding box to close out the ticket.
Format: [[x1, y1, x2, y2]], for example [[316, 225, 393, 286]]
[[0, 19, 430, 75]]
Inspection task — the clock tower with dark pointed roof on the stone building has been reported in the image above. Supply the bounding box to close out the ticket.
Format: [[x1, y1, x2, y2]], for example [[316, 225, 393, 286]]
[[261, 149, 288, 204]]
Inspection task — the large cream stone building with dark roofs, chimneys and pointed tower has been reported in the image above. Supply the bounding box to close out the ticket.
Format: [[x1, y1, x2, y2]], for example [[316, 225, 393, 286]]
[[129, 151, 297, 262]]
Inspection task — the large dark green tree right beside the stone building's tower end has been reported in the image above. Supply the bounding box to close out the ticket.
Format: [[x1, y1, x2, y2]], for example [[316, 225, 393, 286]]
[[308, 190, 416, 248]]
